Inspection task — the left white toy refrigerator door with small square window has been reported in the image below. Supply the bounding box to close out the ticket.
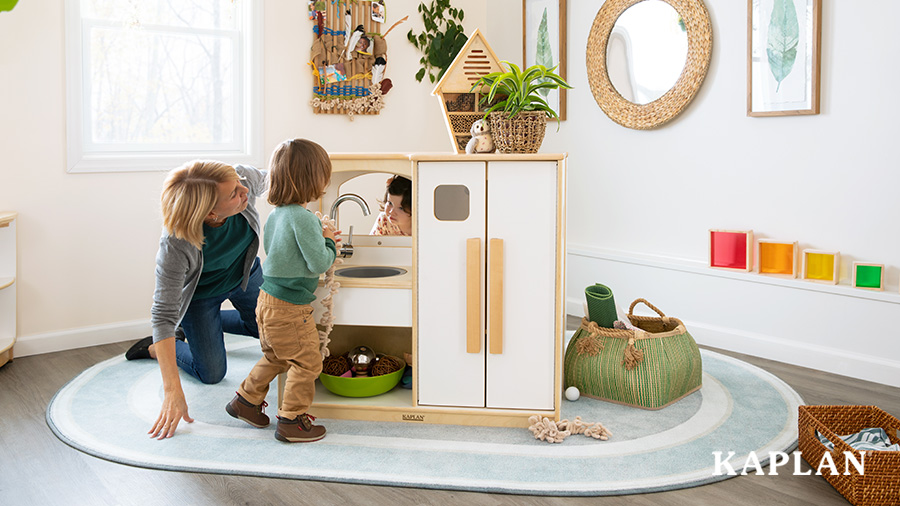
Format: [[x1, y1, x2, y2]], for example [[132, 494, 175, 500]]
[[413, 162, 485, 407]]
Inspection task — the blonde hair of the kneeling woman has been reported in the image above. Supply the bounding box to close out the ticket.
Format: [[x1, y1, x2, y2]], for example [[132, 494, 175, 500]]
[[160, 160, 240, 249]]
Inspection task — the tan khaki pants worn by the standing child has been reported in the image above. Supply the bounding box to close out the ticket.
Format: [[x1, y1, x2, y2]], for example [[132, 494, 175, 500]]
[[238, 290, 322, 419]]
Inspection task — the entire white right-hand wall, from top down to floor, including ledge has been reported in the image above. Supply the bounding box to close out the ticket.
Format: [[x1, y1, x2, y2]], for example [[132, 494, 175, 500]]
[[556, 0, 900, 385]]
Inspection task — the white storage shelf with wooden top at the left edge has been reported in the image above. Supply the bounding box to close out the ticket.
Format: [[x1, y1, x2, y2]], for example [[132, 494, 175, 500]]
[[0, 211, 17, 366]]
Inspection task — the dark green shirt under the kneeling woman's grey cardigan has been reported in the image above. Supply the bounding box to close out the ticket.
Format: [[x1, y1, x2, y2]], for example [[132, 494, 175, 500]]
[[191, 214, 256, 300]]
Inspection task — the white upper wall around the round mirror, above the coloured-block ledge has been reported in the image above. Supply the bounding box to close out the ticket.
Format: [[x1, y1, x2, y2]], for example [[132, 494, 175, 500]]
[[556, 0, 900, 268]]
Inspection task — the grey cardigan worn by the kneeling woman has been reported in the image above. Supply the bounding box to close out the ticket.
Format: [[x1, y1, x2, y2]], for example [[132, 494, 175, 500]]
[[150, 165, 269, 343]]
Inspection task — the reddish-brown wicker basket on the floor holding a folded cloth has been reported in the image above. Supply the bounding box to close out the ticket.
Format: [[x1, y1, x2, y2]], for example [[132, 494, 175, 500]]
[[797, 406, 900, 506]]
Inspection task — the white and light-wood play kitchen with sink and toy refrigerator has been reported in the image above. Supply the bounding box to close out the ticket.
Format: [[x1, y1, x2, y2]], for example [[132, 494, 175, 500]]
[[278, 153, 566, 427]]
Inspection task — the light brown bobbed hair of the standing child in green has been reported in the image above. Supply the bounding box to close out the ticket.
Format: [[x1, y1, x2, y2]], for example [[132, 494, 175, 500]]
[[268, 139, 331, 206]]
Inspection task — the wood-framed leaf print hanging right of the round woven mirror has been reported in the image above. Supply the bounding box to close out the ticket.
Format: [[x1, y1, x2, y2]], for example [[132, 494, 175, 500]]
[[747, 0, 822, 116]]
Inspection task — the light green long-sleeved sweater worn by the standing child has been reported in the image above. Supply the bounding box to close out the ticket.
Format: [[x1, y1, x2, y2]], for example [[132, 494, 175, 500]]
[[260, 204, 337, 304]]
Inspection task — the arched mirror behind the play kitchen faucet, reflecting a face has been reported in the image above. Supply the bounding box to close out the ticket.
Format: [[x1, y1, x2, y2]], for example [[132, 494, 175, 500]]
[[336, 172, 412, 237]]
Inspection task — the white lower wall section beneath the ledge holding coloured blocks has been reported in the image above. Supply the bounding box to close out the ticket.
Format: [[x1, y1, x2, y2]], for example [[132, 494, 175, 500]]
[[566, 244, 900, 387]]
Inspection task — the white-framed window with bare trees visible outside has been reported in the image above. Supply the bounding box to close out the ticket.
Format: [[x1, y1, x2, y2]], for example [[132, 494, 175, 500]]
[[70, 0, 264, 172]]
